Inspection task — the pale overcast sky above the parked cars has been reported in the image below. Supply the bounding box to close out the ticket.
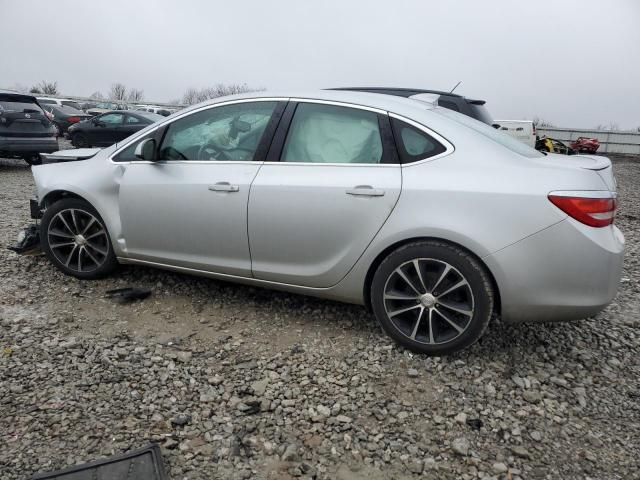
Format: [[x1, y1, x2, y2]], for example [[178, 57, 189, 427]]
[[0, 0, 640, 128]]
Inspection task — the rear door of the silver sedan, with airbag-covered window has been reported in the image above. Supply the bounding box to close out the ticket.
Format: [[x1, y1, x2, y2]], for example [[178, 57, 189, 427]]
[[248, 100, 402, 287]]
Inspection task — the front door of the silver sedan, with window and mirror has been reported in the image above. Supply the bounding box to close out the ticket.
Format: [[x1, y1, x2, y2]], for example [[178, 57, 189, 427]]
[[114, 101, 278, 276]]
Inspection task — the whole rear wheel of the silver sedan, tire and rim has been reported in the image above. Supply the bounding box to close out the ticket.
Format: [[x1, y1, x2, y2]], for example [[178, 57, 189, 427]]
[[371, 241, 494, 355]]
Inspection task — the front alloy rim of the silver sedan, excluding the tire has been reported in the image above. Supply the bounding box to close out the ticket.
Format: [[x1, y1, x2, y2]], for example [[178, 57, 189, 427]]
[[47, 208, 109, 273]]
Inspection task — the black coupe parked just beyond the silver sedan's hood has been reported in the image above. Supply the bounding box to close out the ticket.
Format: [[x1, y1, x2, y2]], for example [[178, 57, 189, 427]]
[[67, 110, 164, 148]]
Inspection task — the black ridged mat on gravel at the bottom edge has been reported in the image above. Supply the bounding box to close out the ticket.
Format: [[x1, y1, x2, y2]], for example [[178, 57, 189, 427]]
[[31, 445, 167, 480]]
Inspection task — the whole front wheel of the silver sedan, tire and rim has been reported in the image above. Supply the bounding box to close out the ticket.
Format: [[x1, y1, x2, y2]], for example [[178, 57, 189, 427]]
[[40, 198, 118, 280]]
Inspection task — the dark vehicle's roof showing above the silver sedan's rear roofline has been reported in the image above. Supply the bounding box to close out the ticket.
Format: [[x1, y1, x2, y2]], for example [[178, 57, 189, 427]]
[[331, 87, 493, 125]]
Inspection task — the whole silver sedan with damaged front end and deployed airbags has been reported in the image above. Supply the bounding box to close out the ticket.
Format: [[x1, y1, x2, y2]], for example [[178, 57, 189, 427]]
[[32, 91, 624, 355]]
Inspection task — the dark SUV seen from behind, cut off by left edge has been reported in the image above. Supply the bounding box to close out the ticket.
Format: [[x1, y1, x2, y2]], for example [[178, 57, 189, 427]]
[[0, 90, 58, 165]]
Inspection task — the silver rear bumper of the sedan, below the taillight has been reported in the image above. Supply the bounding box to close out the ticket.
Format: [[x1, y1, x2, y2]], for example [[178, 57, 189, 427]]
[[484, 218, 624, 322]]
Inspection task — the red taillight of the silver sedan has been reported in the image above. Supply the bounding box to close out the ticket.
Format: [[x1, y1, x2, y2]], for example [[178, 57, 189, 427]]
[[549, 193, 618, 227]]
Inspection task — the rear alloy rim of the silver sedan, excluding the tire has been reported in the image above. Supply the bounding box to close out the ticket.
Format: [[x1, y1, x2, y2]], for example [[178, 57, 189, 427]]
[[383, 258, 474, 345]]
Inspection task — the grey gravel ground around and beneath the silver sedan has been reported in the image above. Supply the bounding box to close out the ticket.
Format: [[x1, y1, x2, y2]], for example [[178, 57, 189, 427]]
[[0, 148, 640, 480]]
